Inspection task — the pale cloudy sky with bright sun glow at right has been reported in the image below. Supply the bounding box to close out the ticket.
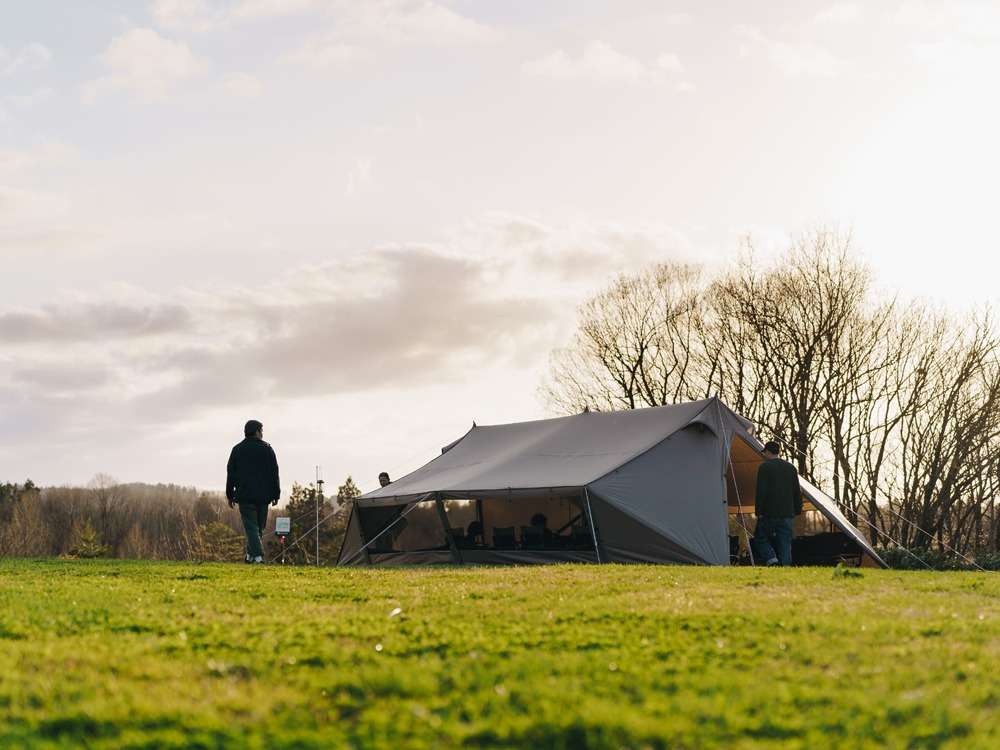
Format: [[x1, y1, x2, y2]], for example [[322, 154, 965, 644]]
[[0, 0, 1000, 490]]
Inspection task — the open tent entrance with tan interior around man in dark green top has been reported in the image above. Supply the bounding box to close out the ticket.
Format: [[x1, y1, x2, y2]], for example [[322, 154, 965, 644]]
[[726, 435, 864, 565]]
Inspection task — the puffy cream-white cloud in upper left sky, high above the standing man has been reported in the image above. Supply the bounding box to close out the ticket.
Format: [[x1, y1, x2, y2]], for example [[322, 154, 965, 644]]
[[82, 28, 207, 102]]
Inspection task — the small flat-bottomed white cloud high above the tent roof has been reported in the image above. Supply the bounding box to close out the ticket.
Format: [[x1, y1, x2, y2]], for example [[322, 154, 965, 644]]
[[521, 40, 684, 83]]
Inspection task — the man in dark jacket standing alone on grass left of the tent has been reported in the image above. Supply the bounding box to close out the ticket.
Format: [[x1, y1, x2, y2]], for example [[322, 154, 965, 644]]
[[226, 419, 281, 563]]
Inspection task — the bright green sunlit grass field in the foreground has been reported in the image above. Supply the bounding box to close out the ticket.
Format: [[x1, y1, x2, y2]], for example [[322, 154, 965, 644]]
[[0, 560, 1000, 750]]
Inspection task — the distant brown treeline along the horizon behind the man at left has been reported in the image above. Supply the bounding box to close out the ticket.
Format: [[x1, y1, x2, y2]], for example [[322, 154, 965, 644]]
[[0, 475, 360, 563]]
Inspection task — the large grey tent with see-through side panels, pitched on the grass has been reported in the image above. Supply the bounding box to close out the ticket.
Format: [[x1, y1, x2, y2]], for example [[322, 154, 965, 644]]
[[338, 398, 884, 566]]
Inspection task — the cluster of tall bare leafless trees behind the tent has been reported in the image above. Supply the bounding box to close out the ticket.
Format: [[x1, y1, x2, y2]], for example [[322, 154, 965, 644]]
[[542, 230, 1000, 554]]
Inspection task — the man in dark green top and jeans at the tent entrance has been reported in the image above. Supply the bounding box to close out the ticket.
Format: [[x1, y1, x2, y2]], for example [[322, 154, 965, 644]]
[[753, 441, 802, 565]]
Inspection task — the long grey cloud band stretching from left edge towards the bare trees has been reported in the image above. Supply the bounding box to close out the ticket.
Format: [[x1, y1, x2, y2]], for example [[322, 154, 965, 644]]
[[0, 214, 682, 419]]
